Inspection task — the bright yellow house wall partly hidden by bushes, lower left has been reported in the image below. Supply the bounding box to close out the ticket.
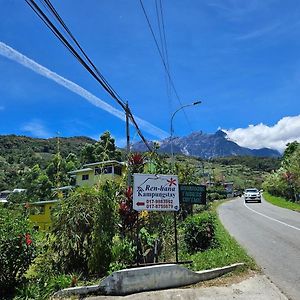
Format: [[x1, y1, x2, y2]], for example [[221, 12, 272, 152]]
[[29, 200, 59, 231]]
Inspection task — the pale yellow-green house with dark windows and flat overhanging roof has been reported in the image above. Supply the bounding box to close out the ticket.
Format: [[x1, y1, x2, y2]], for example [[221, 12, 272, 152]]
[[69, 160, 125, 186]]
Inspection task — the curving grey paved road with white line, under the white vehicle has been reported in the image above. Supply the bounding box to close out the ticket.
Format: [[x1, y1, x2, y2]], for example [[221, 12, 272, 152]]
[[218, 198, 300, 300]]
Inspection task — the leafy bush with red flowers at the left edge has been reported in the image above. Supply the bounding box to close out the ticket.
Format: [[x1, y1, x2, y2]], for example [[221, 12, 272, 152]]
[[0, 207, 35, 298]]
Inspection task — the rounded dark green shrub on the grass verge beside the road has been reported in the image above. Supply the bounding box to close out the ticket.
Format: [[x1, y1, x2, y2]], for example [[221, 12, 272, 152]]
[[184, 212, 217, 253]]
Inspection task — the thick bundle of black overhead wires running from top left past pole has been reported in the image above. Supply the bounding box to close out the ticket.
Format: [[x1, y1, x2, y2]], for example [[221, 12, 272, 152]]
[[25, 0, 152, 151]]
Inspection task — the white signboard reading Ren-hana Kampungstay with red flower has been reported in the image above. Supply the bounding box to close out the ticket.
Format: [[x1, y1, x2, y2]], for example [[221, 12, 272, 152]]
[[133, 174, 179, 211]]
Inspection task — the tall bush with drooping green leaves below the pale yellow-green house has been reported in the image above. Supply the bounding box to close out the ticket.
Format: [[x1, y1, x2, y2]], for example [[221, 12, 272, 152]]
[[52, 182, 117, 275]]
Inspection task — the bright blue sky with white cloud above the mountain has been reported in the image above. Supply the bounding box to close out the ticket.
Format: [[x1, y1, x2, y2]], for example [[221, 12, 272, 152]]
[[0, 0, 300, 150]]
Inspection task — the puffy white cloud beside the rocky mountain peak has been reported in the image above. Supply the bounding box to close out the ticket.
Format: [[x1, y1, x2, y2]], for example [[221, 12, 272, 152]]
[[222, 115, 300, 152]]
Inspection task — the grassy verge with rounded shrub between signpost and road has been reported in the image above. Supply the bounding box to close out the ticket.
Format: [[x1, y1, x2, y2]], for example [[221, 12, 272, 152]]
[[182, 202, 258, 271]]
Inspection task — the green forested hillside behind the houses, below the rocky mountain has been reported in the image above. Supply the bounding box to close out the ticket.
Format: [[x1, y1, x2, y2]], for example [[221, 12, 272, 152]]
[[0, 132, 280, 192]]
